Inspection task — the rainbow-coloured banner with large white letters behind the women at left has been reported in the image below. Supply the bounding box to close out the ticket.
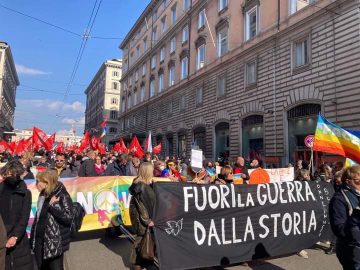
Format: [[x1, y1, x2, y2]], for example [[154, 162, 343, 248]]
[[26, 176, 134, 231]]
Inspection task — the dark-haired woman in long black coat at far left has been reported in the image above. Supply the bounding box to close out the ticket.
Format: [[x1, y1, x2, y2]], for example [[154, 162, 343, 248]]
[[0, 160, 33, 270]]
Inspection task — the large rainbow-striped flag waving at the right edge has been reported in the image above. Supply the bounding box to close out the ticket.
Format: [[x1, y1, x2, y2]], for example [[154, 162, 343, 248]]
[[314, 114, 360, 163]]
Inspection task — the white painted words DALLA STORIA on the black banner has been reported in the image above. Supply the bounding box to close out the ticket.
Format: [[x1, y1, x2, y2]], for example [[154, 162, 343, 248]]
[[194, 210, 316, 246]]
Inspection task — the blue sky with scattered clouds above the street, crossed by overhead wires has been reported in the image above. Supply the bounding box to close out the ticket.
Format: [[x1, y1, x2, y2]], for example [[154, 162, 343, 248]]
[[0, 0, 150, 135]]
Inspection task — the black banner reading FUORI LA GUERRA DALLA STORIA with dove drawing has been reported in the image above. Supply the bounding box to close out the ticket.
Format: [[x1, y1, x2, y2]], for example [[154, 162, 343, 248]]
[[153, 181, 333, 269]]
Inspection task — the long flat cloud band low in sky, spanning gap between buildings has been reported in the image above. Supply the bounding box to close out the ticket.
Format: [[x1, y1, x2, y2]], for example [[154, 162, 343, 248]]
[[17, 99, 85, 113]]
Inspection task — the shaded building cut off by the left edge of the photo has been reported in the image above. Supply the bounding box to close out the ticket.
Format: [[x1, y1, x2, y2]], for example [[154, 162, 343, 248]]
[[0, 41, 20, 140]]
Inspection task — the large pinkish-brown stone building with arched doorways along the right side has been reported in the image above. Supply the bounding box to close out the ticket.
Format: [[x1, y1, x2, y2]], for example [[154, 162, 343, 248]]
[[119, 0, 360, 166]]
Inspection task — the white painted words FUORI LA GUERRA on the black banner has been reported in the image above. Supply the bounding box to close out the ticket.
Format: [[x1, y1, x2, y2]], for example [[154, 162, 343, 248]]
[[183, 181, 316, 212]]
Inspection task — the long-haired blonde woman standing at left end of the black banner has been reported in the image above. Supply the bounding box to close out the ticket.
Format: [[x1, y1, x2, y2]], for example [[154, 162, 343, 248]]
[[129, 162, 157, 269]]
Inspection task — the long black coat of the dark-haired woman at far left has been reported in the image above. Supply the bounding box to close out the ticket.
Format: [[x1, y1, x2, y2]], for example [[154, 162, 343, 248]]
[[0, 179, 33, 270]]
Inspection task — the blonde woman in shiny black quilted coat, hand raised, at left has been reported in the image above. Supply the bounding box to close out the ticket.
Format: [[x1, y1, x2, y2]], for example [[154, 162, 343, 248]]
[[30, 170, 72, 270]]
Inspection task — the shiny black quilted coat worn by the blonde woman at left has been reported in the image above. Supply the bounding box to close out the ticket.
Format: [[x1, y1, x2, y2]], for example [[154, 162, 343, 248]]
[[30, 182, 73, 268]]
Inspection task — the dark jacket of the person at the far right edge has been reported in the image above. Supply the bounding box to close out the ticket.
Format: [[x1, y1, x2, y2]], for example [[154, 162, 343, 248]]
[[329, 189, 360, 269]]
